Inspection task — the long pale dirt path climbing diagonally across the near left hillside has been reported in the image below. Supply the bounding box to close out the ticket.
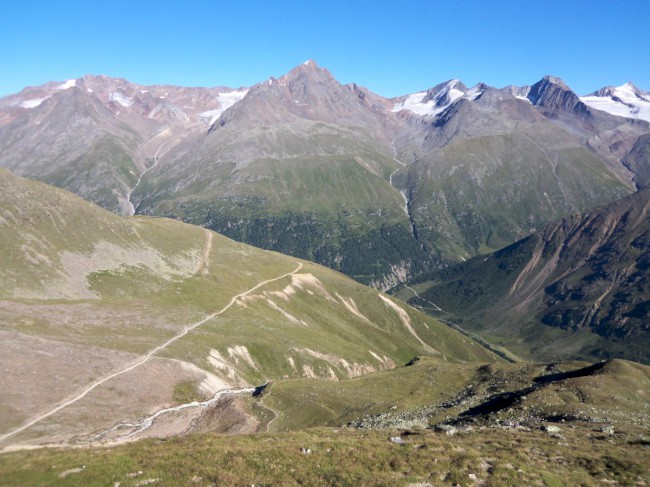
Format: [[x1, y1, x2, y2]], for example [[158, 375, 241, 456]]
[[0, 262, 302, 442]]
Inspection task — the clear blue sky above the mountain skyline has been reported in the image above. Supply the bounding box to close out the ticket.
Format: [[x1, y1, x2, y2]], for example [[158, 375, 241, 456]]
[[0, 0, 650, 96]]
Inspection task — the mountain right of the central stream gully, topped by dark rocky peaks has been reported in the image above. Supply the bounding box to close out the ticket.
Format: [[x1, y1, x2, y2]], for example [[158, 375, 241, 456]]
[[394, 80, 630, 261]]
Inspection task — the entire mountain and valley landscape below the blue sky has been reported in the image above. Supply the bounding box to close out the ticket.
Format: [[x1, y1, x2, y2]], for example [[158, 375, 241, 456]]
[[0, 60, 650, 487]]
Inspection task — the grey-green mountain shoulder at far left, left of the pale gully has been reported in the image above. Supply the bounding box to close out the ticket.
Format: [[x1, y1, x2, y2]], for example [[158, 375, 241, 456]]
[[0, 88, 142, 212]]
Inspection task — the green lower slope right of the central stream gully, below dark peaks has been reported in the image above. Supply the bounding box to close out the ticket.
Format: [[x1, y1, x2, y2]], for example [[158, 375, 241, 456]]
[[400, 128, 629, 261]]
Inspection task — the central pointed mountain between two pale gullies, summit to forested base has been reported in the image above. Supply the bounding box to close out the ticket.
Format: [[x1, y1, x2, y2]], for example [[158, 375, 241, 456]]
[[134, 61, 430, 287]]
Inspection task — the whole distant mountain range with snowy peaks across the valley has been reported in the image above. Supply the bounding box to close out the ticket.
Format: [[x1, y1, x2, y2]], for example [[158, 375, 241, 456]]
[[0, 61, 650, 289]]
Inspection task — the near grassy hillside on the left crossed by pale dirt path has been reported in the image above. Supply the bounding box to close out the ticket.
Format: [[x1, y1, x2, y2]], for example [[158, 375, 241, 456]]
[[0, 170, 495, 448]]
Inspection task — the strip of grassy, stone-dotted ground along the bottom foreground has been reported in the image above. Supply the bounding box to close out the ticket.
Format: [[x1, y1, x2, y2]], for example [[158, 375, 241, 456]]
[[0, 424, 650, 486]]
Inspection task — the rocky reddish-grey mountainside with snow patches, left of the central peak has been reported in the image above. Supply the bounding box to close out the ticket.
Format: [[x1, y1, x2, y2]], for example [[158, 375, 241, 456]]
[[0, 76, 246, 214]]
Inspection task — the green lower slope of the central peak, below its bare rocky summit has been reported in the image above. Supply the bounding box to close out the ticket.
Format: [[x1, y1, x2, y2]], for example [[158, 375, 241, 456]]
[[135, 121, 429, 283]]
